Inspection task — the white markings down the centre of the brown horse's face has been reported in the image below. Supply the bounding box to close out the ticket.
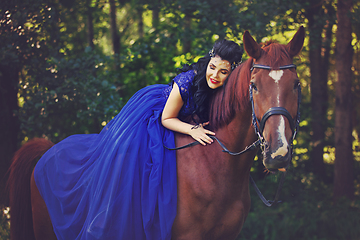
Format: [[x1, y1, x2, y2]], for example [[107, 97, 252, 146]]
[[269, 70, 288, 158]]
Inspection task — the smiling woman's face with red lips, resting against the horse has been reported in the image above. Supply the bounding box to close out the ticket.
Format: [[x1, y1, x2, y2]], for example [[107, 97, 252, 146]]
[[206, 55, 231, 89]]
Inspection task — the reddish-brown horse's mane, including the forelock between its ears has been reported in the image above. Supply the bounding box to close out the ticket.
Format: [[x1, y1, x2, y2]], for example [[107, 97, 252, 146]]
[[210, 40, 291, 130]]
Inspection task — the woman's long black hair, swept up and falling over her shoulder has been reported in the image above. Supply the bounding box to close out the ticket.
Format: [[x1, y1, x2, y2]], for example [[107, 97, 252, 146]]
[[182, 39, 244, 122]]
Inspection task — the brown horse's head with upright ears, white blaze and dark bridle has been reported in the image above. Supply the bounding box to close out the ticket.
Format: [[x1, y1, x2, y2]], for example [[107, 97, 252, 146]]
[[244, 27, 305, 170]]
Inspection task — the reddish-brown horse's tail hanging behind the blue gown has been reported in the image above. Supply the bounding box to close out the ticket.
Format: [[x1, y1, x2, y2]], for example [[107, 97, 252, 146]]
[[7, 138, 54, 240]]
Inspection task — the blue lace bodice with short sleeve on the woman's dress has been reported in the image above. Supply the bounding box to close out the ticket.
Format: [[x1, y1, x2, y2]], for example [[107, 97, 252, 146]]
[[164, 70, 195, 118]]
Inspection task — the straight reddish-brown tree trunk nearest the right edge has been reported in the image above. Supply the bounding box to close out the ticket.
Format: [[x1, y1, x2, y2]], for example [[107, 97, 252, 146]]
[[333, 0, 354, 201]]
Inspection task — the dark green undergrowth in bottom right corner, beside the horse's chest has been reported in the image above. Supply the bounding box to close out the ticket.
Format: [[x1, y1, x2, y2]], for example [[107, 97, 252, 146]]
[[238, 169, 360, 240]]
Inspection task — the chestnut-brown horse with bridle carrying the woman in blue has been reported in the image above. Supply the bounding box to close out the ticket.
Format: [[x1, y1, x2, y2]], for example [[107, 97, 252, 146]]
[[9, 27, 305, 240]]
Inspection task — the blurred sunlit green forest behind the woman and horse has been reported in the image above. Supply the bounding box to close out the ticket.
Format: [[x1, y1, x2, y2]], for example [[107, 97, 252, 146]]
[[0, 0, 360, 240]]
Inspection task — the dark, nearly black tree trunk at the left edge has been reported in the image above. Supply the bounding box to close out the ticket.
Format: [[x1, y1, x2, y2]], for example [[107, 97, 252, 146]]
[[0, 65, 19, 206]]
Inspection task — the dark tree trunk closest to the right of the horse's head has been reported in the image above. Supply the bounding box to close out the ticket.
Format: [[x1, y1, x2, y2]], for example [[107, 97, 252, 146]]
[[305, 1, 332, 181]]
